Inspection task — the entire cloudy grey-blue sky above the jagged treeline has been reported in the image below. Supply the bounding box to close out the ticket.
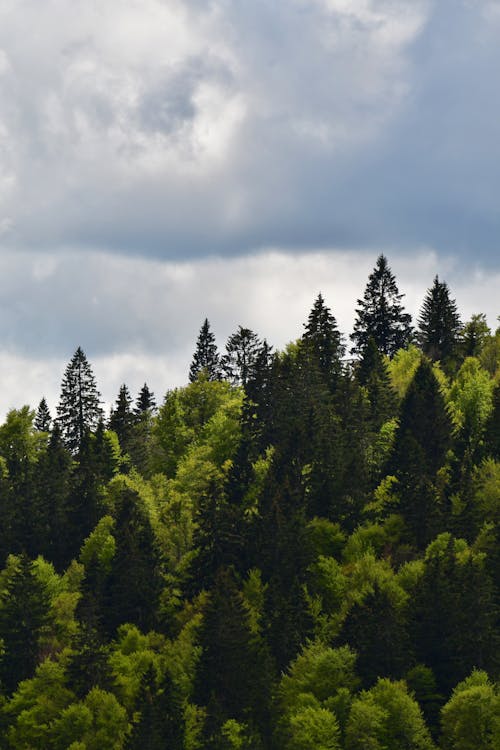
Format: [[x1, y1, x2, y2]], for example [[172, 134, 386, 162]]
[[0, 0, 500, 414]]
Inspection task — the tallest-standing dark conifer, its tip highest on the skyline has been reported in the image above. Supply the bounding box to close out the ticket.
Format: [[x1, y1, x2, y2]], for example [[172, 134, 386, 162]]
[[351, 255, 412, 357]]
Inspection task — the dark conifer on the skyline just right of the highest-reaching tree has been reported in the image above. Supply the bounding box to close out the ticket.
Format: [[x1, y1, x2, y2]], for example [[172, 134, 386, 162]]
[[417, 276, 461, 367]]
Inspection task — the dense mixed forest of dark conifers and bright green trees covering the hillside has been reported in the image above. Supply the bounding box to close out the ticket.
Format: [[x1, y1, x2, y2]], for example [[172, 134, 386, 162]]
[[0, 255, 500, 750]]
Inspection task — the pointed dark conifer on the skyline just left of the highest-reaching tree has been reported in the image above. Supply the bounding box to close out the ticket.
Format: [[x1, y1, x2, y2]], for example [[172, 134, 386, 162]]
[[302, 294, 345, 384]]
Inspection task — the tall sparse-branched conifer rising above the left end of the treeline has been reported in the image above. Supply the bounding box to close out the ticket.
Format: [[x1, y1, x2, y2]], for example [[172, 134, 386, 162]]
[[57, 347, 103, 453]]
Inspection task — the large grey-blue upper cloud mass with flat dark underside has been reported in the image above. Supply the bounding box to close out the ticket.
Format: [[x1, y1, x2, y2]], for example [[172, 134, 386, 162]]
[[0, 0, 500, 264]]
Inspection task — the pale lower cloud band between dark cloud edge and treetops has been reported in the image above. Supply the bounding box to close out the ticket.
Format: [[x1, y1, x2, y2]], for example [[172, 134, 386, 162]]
[[0, 248, 500, 420]]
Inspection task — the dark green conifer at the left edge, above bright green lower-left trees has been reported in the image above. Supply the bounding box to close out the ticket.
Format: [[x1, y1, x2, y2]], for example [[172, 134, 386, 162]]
[[0, 554, 50, 693]]
